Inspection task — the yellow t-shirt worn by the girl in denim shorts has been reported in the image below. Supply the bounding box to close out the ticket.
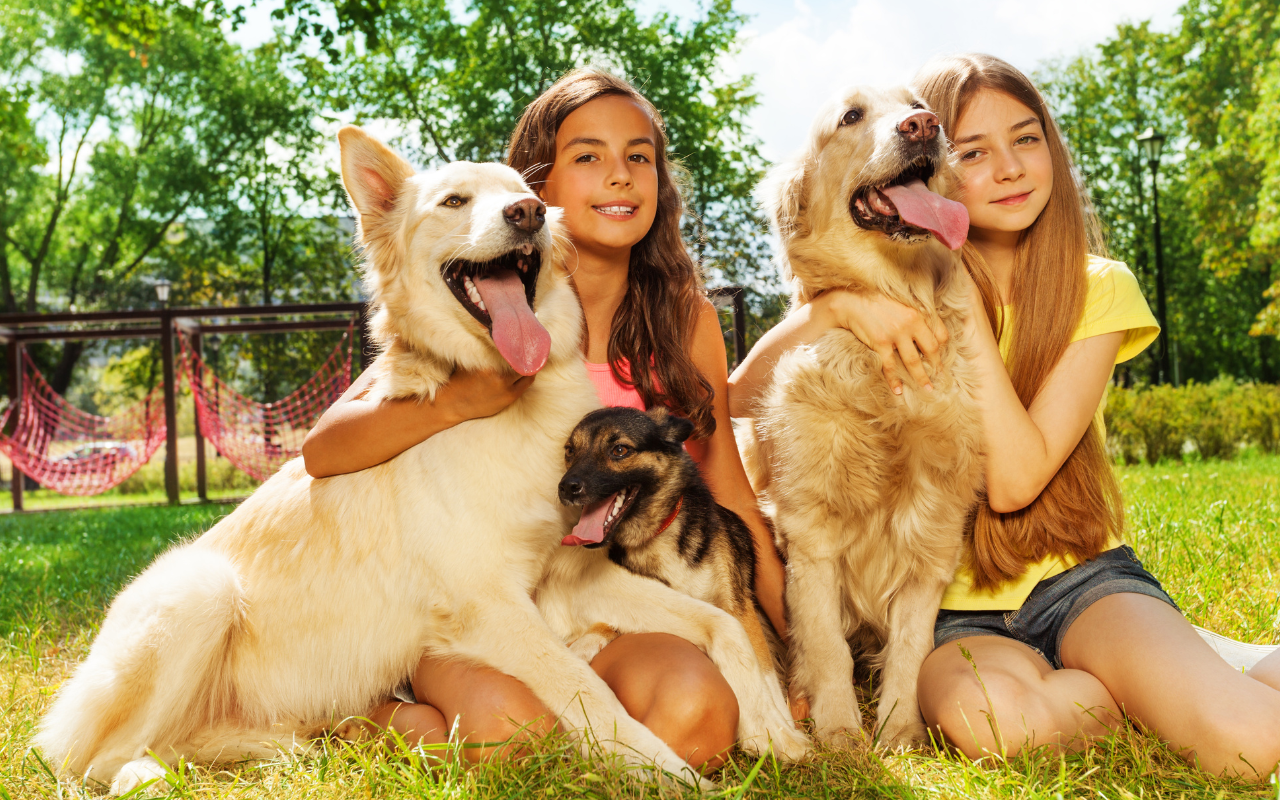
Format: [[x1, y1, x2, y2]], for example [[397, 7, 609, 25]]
[[942, 256, 1160, 611]]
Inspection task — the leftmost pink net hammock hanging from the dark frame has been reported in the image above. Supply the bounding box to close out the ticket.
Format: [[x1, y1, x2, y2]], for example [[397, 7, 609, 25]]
[[0, 351, 165, 497]]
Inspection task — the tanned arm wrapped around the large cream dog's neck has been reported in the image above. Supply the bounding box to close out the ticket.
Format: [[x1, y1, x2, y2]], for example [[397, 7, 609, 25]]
[[302, 353, 534, 477]]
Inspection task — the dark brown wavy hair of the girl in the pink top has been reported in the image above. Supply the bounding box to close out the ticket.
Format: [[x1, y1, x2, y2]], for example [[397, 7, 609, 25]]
[[507, 67, 716, 438]]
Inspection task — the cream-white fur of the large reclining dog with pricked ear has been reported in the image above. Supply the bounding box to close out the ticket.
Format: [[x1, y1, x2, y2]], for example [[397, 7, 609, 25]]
[[36, 128, 805, 792]]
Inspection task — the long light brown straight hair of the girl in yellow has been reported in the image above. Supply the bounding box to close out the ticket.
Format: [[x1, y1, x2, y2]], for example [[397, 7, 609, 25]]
[[915, 54, 1124, 589]]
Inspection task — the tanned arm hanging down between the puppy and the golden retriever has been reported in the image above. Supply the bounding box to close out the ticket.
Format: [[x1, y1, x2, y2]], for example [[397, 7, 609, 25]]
[[691, 296, 787, 640]]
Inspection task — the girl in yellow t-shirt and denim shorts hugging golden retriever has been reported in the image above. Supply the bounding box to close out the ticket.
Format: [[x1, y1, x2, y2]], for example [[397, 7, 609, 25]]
[[731, 54, 1280, 777]]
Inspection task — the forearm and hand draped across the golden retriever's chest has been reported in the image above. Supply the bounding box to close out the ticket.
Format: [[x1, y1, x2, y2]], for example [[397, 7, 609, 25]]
[[728, 289, 947, 417]]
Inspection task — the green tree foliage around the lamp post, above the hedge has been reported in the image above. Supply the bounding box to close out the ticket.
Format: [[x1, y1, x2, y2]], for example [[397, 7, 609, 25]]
[[1038, 0, 1280, 381]]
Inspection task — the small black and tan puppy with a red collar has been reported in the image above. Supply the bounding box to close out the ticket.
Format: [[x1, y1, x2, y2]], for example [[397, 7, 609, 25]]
[[559, 407, 773, 664]]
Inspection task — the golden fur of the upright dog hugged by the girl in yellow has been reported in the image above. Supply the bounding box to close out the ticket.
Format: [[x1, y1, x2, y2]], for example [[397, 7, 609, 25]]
[[740, 88, 982, 746]]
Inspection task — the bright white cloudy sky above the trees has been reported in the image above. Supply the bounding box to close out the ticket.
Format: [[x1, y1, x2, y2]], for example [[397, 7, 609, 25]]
[[225, 0, 1183, 161]]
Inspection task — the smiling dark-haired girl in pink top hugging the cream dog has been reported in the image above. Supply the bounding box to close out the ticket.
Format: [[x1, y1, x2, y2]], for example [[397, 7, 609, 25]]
[[302, 69, 785, 768]]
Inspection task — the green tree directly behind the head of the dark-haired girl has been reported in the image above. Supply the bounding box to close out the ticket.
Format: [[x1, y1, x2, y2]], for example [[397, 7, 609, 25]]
[[296, 0, 778, 353]]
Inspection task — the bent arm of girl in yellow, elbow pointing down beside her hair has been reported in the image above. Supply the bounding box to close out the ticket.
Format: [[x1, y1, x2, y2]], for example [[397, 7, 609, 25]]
[[963, 273, 1125, 513]]
